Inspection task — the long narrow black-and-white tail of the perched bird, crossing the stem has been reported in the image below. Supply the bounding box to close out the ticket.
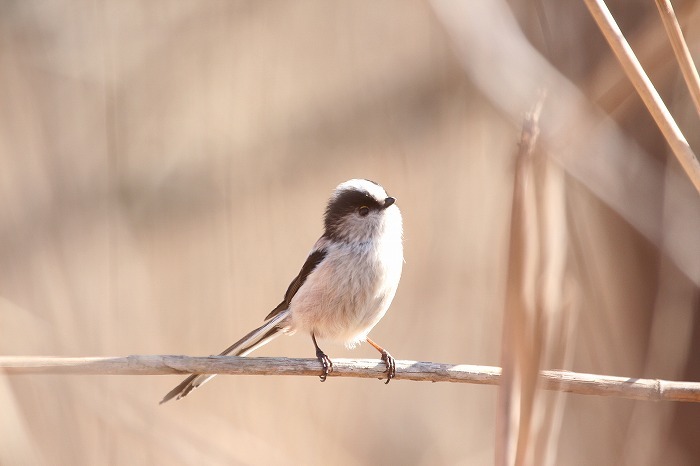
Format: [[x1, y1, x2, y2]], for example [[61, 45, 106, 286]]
[[160, 310, 289, 404]]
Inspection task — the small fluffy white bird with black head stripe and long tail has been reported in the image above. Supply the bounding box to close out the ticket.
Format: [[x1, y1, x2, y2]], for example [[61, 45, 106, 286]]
[[160, 179, 403, 404]]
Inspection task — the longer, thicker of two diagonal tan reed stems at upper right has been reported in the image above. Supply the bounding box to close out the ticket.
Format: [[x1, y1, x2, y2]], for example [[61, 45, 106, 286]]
[[584, 0, 700, 193]]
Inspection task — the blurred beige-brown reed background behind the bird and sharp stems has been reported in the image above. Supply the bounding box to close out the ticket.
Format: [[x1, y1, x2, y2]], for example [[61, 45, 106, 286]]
[[0, 0, 700, 465]]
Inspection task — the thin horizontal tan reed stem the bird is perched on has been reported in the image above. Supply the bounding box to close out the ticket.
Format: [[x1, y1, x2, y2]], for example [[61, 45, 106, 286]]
[[0, 355, 700, 402]]
